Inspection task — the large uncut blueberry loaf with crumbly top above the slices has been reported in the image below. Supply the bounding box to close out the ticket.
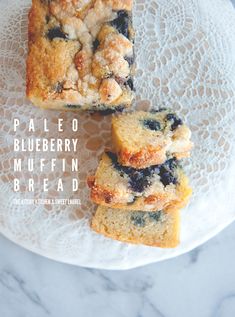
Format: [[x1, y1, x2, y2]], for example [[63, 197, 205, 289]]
[[27, 0, 134, 113]]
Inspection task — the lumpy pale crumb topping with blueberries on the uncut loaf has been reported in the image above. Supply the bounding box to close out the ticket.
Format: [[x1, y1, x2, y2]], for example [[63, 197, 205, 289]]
[[27, 0, 133, 106]]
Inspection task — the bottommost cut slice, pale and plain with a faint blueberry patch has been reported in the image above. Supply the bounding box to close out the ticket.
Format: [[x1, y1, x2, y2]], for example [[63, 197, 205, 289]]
[[91, 206, 180, 248]]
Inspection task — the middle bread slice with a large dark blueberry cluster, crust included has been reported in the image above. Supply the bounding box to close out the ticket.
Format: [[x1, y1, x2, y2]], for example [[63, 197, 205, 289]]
[[88, 152, 191, 211]]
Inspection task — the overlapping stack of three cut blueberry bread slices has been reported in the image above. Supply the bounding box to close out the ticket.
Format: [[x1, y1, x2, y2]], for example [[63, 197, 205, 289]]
[[88, 109, 192, 248]]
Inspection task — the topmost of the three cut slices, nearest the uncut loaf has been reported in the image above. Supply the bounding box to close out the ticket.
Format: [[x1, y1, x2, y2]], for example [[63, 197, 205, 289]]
[[112, 109, 192, 168]]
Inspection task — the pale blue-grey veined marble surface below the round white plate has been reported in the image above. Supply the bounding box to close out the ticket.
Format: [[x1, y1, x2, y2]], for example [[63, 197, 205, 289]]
[[0, 223, 235, 317]]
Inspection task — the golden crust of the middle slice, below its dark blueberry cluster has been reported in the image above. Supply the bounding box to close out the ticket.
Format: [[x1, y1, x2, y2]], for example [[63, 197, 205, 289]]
[[88, 154, 192, 211]]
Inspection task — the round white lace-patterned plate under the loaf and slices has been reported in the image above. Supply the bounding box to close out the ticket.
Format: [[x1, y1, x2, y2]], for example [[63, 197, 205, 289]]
[[0, 0, 235, 269]]
